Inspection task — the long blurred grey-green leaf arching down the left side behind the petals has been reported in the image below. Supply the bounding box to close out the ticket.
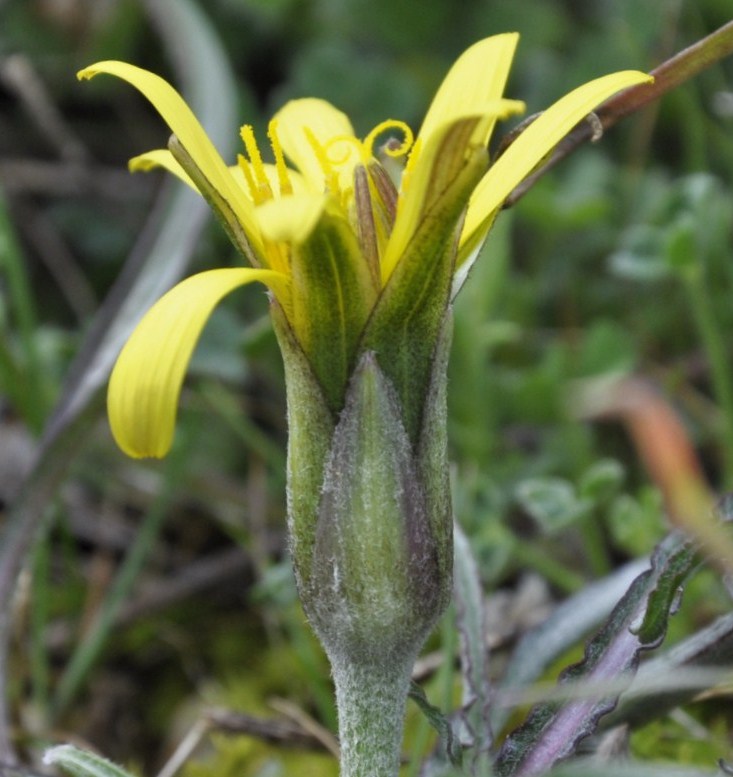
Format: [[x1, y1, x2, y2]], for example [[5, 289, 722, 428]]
[[0, 0, 236, 760]]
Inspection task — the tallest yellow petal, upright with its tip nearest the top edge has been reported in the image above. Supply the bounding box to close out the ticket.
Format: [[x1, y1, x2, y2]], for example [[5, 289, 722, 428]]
[[418, 32, 519, 143]]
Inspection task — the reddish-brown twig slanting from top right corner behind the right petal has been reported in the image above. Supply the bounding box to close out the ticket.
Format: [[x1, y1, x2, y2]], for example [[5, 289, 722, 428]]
[[504, 21, 733, 208]]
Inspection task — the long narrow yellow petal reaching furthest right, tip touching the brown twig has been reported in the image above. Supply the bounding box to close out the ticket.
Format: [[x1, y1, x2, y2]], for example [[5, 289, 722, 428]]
[[459, 70, 652, 255]]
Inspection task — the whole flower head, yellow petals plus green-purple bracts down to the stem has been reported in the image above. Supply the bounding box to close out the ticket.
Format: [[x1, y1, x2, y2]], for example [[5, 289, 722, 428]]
[[79, 34, 648, 667]]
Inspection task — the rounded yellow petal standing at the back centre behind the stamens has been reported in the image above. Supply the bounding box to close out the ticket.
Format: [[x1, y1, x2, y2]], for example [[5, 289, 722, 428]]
[[274, 97, 359, 192]]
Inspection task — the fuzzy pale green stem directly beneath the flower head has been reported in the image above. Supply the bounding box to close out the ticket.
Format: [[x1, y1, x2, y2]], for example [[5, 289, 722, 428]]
[[331, 656, 412, 777]]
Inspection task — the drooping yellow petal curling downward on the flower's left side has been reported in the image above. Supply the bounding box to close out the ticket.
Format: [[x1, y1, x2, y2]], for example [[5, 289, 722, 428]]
[[107, 268, 288, 458]]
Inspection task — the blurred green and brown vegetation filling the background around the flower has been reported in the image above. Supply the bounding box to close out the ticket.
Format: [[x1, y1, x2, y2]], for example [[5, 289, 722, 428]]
[[0, 0, 733, 777]]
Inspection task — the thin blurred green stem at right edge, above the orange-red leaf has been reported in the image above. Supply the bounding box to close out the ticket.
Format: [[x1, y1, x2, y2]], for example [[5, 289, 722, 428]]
[[685, 268, 733, 488]]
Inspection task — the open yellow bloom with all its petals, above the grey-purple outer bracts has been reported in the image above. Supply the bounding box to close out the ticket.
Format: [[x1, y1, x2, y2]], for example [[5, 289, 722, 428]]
[[79, 34, 649, 457]]
